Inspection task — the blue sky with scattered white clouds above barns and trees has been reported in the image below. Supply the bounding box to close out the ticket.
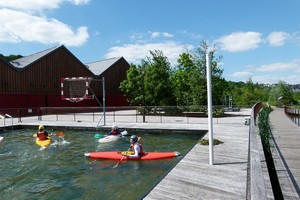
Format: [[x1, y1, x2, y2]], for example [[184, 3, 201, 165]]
[[0, 0, 300, 84]]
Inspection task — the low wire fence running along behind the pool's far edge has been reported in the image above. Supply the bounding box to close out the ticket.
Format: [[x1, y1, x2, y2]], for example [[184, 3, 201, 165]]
[[0, 106, 248, 126]]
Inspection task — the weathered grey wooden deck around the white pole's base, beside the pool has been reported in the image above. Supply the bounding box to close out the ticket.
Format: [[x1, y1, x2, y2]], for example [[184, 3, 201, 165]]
[[144, 117, 249, 200]]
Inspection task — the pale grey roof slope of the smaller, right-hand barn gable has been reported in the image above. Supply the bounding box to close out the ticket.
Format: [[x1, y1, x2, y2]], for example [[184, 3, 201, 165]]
[[85, 57, 122, 75]]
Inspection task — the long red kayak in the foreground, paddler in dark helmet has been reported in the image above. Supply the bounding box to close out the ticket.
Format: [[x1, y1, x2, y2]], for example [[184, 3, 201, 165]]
[[84, 151, 180, 160]]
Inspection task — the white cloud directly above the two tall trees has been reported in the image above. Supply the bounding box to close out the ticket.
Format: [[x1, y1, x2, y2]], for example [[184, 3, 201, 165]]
[[105, 41, 193, 65]]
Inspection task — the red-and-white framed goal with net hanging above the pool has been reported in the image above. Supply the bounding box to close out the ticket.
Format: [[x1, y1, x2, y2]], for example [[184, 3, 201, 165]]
[[61, 77, 94, 103]]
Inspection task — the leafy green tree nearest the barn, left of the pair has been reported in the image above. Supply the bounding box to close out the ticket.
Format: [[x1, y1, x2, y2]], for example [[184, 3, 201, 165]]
[[120, 50, 175, 106]]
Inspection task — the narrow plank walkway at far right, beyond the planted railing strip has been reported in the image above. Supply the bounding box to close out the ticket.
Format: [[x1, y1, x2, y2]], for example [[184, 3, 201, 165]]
[[270, 108, 300, 199]]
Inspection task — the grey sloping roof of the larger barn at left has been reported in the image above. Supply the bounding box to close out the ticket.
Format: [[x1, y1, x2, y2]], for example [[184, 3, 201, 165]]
[[10, 46, 61, 69]]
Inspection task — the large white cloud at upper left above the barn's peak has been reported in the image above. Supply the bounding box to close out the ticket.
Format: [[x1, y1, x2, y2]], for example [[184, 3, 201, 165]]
[[0, 9, 89, 46]]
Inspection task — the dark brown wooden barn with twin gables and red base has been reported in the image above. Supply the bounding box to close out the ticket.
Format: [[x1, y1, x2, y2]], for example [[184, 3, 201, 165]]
[[0, 45, 129, 115]]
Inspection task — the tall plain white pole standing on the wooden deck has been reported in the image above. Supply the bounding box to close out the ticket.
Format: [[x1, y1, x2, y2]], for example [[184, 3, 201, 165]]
[[206, 51, 214, 165]]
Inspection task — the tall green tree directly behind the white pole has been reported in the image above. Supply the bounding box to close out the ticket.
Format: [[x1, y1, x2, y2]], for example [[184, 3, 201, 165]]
[[173, 41, 226, 106]]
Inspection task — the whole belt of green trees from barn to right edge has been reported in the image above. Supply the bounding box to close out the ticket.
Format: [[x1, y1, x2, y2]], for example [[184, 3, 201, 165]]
[[120, 41, 299, 108]]
